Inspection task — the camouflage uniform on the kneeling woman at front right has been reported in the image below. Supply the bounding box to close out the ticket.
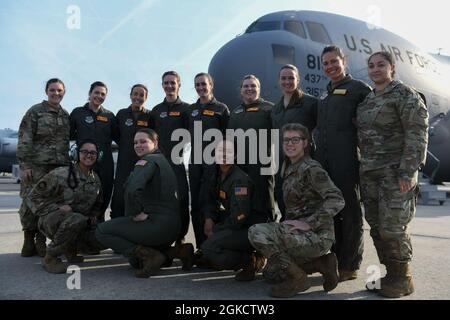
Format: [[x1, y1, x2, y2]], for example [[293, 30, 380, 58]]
[[248, 156, 345, 279]]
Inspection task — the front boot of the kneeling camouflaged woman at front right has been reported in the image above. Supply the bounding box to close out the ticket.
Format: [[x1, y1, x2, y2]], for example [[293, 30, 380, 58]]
[[270, 263, 311, 298]]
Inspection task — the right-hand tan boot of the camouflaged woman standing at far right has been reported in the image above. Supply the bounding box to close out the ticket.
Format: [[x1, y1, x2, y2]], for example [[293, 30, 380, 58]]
[[377, 262, 414, 298]]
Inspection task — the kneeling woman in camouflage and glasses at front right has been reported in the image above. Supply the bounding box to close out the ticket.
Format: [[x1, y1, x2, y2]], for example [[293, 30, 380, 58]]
[[248, 123, 345, 298]]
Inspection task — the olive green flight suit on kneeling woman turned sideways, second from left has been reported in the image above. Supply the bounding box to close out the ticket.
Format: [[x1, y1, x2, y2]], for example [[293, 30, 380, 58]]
[[95, 150, 181, 257]]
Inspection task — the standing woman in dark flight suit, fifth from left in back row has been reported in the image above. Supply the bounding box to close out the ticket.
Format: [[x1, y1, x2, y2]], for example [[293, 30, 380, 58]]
[[189, 73, 230, 256]]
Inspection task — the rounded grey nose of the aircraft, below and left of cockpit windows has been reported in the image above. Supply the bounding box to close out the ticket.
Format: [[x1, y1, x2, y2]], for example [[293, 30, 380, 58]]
[[209, 34, 272, 110]]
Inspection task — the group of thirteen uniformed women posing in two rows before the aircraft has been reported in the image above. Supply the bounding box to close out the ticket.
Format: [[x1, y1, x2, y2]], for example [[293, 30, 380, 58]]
[[17, 45, 428, 297]]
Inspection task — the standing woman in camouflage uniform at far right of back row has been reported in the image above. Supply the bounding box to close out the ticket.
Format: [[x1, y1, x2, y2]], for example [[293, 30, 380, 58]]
[[357, 52, 428, 298]]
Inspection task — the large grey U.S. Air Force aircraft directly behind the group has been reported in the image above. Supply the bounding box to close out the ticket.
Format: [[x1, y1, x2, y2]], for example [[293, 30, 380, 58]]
[[209, 11, 450, 183]]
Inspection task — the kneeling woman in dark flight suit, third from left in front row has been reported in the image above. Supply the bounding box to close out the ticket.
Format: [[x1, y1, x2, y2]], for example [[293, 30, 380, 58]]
[[197, 140, 268, 281]]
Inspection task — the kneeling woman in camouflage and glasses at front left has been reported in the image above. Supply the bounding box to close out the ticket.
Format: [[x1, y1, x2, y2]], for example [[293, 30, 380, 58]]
[[25, 140, 102, 273]]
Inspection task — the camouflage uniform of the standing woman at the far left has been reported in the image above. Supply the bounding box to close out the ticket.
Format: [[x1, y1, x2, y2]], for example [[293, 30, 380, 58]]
[[17, 101, 69, 231]]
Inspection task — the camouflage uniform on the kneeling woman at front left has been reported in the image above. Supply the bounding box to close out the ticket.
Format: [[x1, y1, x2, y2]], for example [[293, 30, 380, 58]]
[[26, 164, 102, 256]]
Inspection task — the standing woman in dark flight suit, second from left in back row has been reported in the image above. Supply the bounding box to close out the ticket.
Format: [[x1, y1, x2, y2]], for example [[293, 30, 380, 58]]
[[70, 81, 119, 222]]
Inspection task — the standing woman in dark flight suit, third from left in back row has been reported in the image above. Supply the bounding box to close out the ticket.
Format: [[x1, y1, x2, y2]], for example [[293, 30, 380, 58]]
[[111, 84, 150, 219]]
